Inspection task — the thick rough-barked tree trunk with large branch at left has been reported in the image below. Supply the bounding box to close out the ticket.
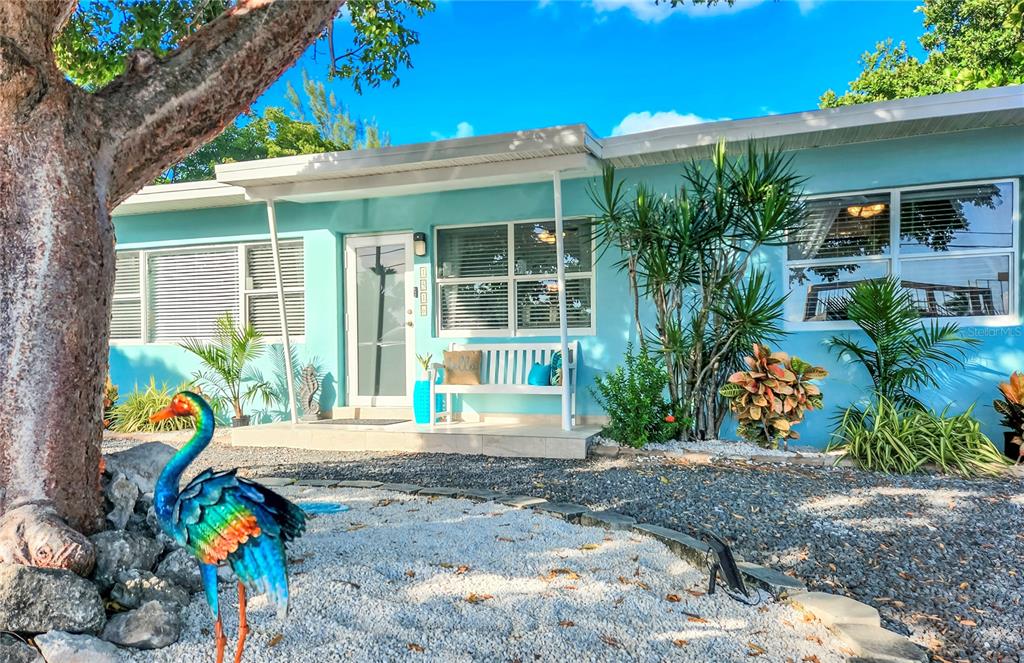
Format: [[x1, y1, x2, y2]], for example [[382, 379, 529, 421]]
[[0, 0, 343, 573]]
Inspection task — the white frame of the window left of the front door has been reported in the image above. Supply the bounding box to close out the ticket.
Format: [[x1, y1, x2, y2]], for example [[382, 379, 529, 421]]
[[110, 237, 308, 346]]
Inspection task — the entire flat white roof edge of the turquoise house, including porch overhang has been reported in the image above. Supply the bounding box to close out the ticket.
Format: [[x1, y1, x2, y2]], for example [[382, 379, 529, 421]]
[[115, 86, 1024, 215]]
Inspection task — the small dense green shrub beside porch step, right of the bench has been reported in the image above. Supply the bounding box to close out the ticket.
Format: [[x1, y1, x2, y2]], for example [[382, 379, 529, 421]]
[[590, 345, 689, 448]]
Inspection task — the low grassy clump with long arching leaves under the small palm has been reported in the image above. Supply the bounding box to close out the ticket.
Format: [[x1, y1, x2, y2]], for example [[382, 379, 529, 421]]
[[829, 398, 1009, 476]]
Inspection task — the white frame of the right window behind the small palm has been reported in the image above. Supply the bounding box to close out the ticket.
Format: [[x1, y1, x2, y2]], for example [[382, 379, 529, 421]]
[[779, 177, 1021, 331]]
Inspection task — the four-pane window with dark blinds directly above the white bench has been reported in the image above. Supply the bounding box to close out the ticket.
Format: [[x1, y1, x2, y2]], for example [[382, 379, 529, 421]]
[[434, 219, 594, 336]]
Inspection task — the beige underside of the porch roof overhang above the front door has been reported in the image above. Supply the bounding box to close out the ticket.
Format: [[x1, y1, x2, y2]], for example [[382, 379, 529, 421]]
[[246, 154, 601, 203]]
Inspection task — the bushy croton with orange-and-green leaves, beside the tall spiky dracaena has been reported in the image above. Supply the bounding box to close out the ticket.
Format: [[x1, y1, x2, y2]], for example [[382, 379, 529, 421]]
[[719, 343, 828, 449]]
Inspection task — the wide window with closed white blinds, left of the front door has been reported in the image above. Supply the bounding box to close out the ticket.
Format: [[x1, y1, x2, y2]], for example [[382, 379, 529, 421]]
[[111, 241, 306, 343]]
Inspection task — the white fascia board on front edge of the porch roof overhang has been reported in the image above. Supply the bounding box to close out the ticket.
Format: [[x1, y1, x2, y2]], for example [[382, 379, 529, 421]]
[[216, 124, 599, 187]]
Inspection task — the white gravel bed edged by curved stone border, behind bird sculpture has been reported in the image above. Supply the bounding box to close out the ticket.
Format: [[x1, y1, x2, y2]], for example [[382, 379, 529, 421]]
[[129, 488, 844, 663]]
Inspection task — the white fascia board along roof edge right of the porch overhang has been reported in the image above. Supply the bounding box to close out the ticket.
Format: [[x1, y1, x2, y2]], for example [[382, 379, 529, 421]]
[[602, 85, 1024, 159]]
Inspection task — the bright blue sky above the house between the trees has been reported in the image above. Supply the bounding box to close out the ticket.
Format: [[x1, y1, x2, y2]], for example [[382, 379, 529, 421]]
[[251, 0, 922, 144]]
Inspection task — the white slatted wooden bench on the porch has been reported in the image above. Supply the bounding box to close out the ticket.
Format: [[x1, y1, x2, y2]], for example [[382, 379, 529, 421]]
[[429, 340, 580, 424]]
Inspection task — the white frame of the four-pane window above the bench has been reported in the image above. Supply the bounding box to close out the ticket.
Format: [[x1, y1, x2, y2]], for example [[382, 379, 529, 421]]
[[430, 216, 597, 338]]
